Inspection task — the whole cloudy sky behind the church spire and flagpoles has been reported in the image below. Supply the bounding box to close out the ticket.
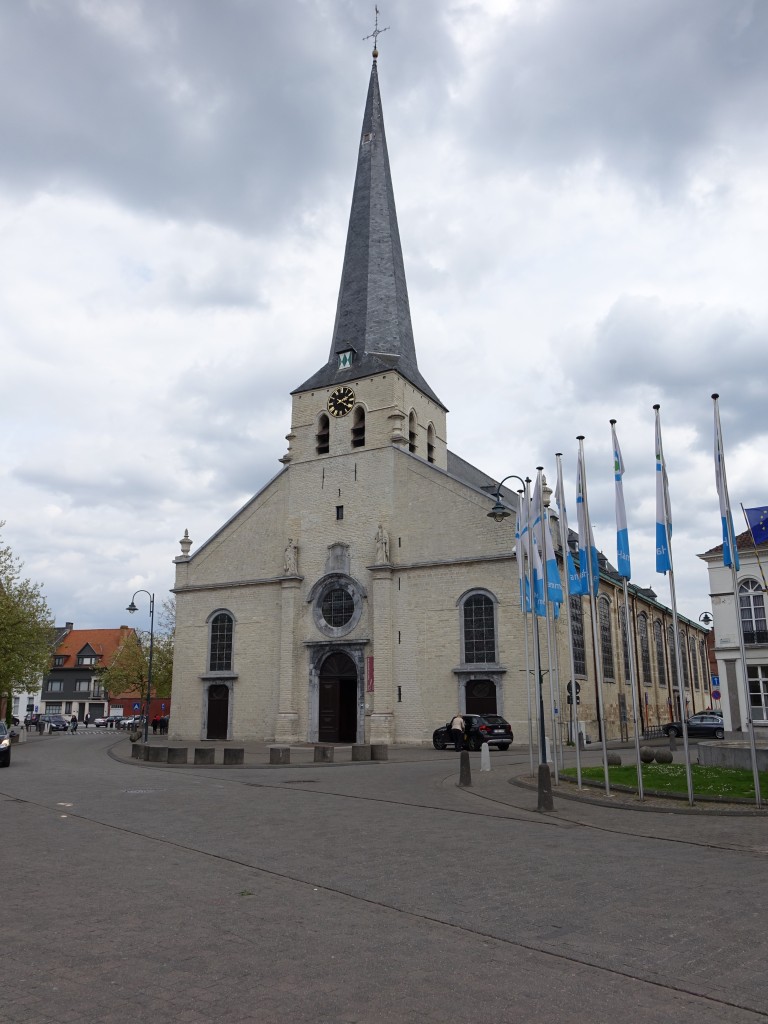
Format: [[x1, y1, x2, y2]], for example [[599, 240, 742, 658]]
[[0, 0, 768, 627]]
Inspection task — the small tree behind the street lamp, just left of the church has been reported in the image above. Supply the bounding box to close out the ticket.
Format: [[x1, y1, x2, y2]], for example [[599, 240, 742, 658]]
[[99, 598, 176, 697]]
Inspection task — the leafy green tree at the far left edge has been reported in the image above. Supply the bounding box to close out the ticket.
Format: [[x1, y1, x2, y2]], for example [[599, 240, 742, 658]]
[[0, 521, 55, 720]]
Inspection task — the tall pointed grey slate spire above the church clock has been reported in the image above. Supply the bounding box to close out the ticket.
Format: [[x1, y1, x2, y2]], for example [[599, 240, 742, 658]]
[[294, 57, 444, 408]]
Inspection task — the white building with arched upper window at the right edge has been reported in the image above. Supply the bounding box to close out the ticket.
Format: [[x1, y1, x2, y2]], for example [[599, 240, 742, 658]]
[[699, 529, 768, 739]]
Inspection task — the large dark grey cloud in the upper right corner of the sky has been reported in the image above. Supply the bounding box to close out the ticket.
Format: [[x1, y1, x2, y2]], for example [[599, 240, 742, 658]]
[[460, 0, 768, 193]]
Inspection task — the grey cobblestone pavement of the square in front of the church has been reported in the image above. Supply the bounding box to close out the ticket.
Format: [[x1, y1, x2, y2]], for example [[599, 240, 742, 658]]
[[0, 729, 768, 1024]]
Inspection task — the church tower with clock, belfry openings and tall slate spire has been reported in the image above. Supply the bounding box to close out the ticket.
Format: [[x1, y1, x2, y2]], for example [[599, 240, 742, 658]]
[[282, 50, 447, 469]]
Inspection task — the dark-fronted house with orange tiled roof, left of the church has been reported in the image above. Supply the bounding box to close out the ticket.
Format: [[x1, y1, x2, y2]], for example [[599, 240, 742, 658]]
[[40, 623, 135, 722]]
